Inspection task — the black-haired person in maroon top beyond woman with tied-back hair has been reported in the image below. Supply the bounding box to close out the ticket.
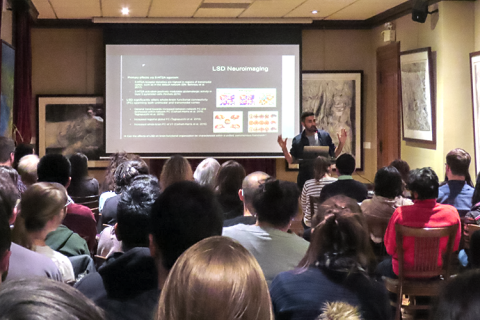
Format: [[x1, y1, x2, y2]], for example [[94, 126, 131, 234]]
[[37, 154, 97, 254]]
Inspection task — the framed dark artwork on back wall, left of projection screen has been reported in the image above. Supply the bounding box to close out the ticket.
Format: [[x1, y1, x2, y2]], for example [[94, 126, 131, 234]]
[[37, 96, 108, 167]]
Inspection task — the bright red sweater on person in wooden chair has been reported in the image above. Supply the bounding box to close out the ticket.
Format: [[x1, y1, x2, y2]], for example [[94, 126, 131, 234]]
[[384, 199, 462, 275]]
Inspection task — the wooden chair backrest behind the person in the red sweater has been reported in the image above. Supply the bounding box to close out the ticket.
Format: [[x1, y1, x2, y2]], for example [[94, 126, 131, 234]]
[[395, 224, 458, 280]]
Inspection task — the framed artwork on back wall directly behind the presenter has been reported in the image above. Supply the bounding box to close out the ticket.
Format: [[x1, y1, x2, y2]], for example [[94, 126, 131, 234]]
[[301, 71, 363, 170]]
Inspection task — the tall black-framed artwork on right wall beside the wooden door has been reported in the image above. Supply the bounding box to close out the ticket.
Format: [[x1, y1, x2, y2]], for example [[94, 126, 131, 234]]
[[400, 47, 436, 144]]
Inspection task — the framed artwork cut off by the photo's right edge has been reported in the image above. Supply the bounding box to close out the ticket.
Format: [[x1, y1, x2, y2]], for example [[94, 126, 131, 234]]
[[470, 51, 480, 172]]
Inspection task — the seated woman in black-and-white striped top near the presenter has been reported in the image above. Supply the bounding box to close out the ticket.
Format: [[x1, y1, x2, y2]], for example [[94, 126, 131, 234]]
[[300, 156, 337, 227]]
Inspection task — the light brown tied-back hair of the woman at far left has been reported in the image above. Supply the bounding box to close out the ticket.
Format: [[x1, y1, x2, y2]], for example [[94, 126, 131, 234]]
[[12, 182, 67, 249]]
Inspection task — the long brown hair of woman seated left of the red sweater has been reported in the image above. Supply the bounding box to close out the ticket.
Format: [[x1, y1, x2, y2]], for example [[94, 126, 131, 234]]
[[298, 196, 375, 269]]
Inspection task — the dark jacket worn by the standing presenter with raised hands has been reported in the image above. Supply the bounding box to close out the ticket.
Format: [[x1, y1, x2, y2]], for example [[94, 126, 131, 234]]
[[290, 130, 335, 190]]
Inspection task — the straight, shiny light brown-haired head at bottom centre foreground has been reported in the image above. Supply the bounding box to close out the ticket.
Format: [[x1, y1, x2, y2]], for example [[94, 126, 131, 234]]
[[156, 237, 273, 320]]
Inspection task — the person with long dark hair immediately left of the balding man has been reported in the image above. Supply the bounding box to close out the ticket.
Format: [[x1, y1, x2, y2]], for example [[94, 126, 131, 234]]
[[215, 160, 246, 219]]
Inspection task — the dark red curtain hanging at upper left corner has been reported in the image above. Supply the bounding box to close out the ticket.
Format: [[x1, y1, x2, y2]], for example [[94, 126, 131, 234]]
[[12, 0, 33, 143]]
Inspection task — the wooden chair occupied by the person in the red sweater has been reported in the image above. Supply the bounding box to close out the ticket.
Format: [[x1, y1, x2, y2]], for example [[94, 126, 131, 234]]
[[384, 224, 458, 320]]
